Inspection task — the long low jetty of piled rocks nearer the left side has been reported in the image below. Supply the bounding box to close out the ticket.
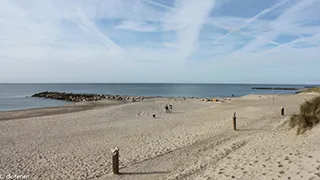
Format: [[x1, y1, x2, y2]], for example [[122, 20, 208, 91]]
[[31, 91, 160, 102]]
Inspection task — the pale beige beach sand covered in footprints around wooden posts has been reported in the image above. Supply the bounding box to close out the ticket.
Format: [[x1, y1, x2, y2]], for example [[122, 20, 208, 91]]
[[0, 93, 320, 180]]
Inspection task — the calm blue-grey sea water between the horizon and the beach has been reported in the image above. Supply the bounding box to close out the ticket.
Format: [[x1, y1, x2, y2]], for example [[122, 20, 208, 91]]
[[0, 83, 312, 111]]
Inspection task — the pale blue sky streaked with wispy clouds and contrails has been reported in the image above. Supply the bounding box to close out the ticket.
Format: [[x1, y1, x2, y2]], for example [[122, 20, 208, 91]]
[[0, 0, 320, 84]]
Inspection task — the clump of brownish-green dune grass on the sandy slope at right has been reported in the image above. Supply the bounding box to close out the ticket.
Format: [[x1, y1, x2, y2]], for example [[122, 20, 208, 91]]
[[289, 96, 320, 135]]
